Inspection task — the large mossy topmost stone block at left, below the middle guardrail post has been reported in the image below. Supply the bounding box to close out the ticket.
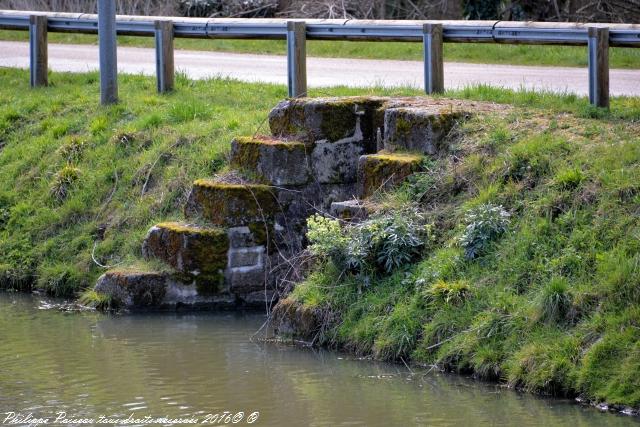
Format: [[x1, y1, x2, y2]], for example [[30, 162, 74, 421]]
[[269, 97, 385, 152]]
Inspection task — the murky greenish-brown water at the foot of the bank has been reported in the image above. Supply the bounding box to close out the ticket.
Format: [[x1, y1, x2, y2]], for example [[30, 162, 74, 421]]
[[0, 293, 639, 427]]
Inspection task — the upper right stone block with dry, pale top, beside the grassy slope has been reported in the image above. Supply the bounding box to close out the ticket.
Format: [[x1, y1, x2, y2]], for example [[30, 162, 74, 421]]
[[384, 106, 465, 155]]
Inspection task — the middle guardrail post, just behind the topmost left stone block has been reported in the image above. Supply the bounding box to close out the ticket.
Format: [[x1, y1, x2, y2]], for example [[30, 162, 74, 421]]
[[287, 21, 307, 98]]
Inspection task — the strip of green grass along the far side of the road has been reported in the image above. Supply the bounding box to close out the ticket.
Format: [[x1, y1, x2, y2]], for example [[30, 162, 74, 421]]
[[0, 30, 640, 68]]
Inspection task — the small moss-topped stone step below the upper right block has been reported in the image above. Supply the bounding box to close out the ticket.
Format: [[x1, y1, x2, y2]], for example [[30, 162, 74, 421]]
[[358, 152, 424, 198]]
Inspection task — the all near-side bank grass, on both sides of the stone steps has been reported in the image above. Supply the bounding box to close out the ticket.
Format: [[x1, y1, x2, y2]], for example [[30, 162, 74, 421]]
[[0, 68, 640, 405]]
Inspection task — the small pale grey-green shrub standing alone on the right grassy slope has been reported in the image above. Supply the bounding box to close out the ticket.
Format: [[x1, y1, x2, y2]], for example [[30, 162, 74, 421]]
[[459, 204, 509, 259]]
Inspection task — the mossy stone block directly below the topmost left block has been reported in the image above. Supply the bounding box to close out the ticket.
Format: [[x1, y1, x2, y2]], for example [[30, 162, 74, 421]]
[[231, 137, 310, 185]]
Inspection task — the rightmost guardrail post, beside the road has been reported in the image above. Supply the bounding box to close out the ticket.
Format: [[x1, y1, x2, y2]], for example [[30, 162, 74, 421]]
[[587, 27, 609, 108]]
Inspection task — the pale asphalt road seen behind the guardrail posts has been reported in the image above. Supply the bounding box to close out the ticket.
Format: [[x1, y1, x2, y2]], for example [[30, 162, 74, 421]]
[[0, 41, 640, 96]]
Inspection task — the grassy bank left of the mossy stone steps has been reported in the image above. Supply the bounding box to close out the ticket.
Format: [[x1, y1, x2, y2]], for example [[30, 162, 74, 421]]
[[0, 69, 286, 295]]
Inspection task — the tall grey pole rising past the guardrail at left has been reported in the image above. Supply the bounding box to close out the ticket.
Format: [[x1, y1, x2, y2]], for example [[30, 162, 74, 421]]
[[98, 0, 118, 105]]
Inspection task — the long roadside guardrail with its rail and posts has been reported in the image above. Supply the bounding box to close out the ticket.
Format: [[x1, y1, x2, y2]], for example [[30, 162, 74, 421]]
[[0, 8, 640, 107]]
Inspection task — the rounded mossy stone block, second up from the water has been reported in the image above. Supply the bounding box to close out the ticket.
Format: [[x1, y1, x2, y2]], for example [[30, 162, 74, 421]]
[[142, 222, 229, 276]]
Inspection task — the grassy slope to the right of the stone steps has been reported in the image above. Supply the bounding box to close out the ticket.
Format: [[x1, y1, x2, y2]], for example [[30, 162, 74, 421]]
[[290, 87, 640, 407]]
